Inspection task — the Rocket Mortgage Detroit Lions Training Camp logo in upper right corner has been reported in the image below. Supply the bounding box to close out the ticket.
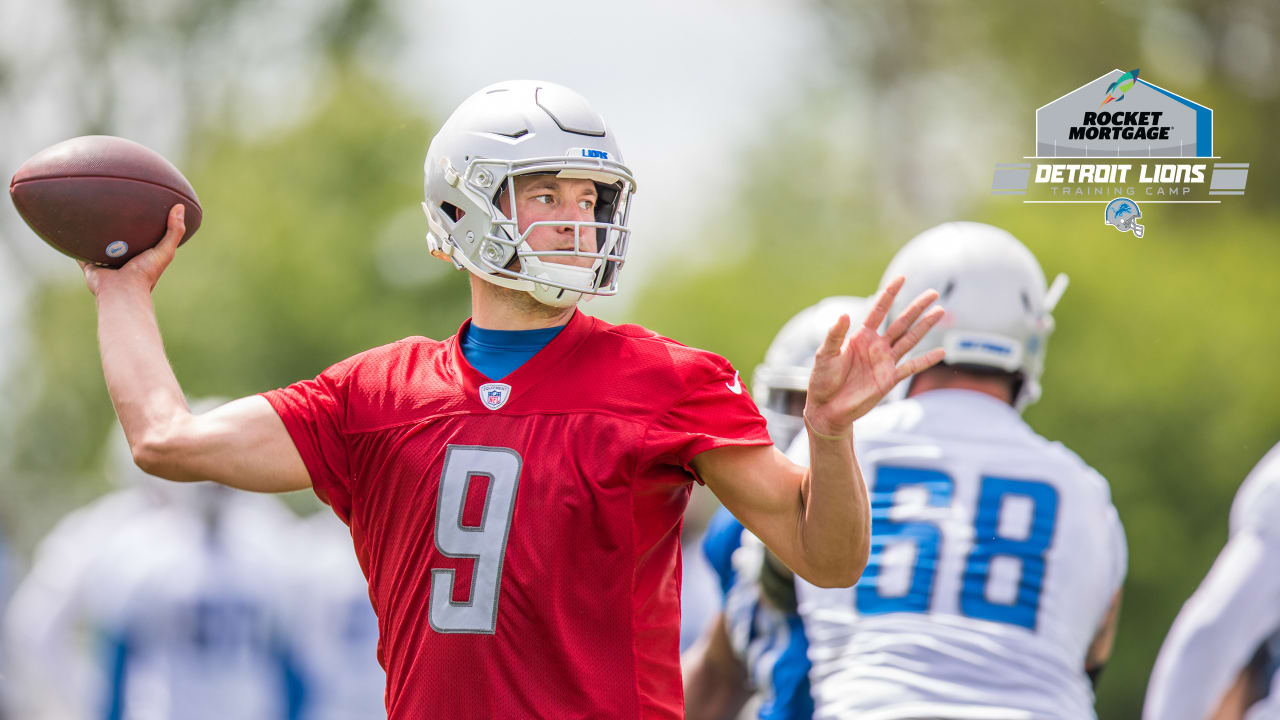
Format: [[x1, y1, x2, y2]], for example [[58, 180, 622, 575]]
[[991, 68, 1249, 237]]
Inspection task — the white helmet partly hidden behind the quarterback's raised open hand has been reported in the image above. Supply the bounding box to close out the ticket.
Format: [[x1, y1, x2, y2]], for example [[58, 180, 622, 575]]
[[751, 296, 870, 451]]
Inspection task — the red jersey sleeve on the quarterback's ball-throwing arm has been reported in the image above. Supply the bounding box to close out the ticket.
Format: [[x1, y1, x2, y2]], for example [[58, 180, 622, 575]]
[[261, 356, 358, 524]]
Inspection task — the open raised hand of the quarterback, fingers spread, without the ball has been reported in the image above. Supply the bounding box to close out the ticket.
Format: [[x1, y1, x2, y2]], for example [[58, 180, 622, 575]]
[[804, 277, 945, 437]]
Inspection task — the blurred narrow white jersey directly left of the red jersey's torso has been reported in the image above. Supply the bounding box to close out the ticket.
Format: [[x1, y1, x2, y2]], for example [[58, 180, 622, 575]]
[[288, 510, 387, 720]]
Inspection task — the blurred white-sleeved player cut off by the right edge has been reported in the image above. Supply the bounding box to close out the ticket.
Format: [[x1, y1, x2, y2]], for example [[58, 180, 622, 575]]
[[1143, 445, 1280, 720]]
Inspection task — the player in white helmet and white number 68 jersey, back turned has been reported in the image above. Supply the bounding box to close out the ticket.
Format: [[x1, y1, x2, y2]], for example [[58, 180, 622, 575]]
[[792, 223, 1128, 720]]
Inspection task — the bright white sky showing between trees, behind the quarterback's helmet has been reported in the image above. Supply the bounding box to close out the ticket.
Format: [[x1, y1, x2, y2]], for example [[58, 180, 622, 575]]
[[0, 0, 819, 374]]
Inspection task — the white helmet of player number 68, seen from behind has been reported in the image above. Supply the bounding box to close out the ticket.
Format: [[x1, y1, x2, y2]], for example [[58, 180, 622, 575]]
[[881, 223, 1068, 411]]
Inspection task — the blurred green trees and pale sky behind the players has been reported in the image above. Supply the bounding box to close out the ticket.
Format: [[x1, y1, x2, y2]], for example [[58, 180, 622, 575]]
[[0, 0, 1280, 719]]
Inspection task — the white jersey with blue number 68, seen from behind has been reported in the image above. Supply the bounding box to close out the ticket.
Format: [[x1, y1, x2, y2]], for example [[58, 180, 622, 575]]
[[792, 389, 1128, 720]]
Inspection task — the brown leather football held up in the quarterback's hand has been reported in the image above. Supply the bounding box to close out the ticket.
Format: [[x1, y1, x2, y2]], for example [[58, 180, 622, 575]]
[[9, 135, 204, 268]]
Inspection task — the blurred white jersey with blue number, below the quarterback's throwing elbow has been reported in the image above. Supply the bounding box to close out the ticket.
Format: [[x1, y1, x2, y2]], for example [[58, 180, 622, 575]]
[[84, 487, 303, 720]]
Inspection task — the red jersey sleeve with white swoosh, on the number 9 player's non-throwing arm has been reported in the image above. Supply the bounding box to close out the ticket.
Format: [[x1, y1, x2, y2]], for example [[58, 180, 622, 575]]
[[645, 352, 771, 482]]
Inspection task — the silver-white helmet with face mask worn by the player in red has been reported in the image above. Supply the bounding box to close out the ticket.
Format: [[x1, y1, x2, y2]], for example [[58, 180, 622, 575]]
[[422, 81, 635, 307]]
